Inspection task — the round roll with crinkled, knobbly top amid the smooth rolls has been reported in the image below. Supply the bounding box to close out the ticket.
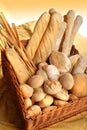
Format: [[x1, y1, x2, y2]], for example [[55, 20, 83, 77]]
[[44, 80, 62, 95]]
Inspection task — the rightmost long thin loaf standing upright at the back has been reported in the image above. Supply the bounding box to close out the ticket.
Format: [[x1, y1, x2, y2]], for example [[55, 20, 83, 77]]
[[68, 15, 83, 55]]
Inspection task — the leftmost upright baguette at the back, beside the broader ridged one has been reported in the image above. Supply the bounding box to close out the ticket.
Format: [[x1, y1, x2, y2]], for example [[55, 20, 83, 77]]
[[26, 12, 50, 59]]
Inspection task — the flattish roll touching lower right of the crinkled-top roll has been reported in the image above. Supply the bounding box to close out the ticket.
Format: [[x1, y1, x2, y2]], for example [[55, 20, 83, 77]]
[[53, 89, 69, 101]]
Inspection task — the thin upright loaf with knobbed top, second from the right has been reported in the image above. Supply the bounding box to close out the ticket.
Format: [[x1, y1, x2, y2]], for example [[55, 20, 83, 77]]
[[62, 10, 75, 55]]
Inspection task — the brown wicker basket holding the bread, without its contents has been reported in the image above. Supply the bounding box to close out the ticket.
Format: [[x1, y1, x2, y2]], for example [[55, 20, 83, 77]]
[[2, 48, 87, 130]]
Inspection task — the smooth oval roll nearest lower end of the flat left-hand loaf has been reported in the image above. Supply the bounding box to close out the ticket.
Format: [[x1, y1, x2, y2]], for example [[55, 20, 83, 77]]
[[27, 75, 44, 88]]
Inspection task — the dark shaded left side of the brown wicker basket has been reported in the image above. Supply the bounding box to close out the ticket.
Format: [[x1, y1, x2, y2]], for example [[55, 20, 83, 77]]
[[2, 52, 26, 119]]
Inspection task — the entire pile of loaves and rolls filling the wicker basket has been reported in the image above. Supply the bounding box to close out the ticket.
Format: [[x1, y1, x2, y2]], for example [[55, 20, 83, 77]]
[[1, 9, 87, 119]]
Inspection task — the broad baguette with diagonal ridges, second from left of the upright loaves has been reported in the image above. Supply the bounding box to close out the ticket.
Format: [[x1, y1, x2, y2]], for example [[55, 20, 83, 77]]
[[33, 12, 62, 64]]
